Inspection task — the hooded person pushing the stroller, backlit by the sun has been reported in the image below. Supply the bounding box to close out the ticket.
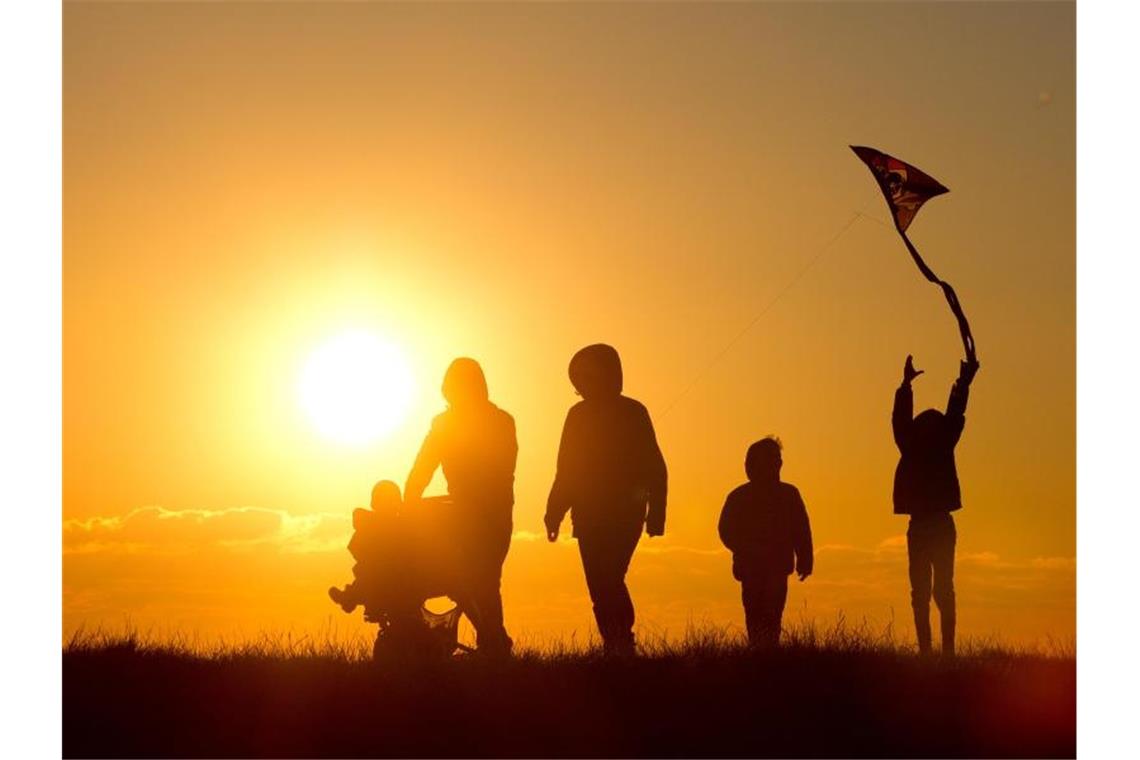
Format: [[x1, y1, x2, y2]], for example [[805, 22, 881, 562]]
[[404, 358, 519, 654]]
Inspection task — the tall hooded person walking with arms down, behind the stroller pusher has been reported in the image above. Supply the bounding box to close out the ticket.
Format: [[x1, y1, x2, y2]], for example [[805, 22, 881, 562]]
[[545, 344, 667, 653]]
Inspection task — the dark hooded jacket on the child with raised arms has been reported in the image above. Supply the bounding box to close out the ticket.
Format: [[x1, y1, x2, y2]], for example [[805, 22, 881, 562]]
[[890, 381, 969, 516]]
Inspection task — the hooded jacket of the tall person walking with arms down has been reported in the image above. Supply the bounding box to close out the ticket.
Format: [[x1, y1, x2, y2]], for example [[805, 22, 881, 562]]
[[546, 344, 668, 536]]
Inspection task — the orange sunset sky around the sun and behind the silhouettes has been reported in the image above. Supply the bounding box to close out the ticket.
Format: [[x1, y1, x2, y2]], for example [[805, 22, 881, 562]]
[[63, 2, 1076, 640]]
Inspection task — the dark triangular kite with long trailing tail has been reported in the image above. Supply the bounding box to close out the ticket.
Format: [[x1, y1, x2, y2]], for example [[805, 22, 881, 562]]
[[850, 145, 978, 365]]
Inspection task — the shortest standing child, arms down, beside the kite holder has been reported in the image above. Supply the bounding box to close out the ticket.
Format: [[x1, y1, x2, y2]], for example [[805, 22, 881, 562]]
[[718, 436, 813, 646]]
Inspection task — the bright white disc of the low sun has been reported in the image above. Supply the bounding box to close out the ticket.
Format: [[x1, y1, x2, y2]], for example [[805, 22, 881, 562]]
[[296, 330, 414, 446]]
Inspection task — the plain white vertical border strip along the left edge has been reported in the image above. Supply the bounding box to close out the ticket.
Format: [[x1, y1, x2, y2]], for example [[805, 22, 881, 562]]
[[0, 2, 63, 758]]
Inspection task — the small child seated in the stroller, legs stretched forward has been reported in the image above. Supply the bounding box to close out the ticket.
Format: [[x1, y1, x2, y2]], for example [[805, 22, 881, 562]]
[[328, 481, 401, 612]]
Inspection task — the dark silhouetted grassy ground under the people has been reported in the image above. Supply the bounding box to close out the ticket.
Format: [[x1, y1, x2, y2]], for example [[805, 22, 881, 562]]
[[63, 621, 1076, 758]]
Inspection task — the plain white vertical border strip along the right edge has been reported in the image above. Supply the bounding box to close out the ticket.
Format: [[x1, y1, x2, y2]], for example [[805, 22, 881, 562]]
[[1077, 0, 1140, 758]]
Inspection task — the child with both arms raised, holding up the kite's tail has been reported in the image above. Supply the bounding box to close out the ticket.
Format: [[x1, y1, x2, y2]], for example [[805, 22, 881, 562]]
[[890, 357, 978, 655]]
